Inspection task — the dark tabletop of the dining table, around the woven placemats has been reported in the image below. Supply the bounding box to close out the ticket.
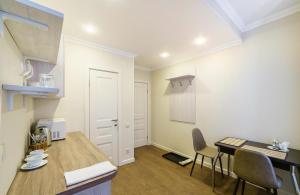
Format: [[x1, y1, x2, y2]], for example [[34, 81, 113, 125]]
[[215, 138, 300, 167]]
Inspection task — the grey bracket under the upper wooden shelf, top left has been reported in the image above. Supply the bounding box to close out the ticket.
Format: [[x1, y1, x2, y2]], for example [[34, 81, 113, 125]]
[[0, 10, 49, 37]]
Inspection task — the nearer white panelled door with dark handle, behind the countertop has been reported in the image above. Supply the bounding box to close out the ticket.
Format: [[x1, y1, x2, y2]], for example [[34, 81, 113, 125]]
[[90, 70, 118, 164]]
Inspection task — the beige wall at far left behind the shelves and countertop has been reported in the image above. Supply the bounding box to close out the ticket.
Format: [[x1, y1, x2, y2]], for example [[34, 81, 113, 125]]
[[0, 26, 33, 195]]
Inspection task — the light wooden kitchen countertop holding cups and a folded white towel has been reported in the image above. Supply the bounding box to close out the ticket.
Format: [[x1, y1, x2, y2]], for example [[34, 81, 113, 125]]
[[8, 132, 117, 195]]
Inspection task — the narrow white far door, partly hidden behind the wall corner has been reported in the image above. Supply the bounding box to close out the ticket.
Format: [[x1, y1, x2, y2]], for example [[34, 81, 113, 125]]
[[134, 82, 148, 147]]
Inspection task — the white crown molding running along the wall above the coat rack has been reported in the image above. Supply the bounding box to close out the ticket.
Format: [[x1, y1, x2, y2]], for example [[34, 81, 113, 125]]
[[151, 39, 243, 71]]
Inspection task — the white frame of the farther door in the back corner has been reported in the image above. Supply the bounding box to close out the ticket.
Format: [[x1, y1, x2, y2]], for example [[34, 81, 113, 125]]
[[133, 80, 152, 145]]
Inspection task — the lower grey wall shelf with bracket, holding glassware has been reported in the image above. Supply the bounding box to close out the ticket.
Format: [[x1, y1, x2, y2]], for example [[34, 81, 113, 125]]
[[2, 84, 59, 111]]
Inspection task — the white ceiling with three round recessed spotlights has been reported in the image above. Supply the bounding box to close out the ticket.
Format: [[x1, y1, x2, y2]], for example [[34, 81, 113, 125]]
[[34, 0, 300, 69]]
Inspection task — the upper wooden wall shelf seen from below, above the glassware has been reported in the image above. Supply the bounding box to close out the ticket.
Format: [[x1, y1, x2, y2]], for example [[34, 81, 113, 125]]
[[0, 0, 64, 64]]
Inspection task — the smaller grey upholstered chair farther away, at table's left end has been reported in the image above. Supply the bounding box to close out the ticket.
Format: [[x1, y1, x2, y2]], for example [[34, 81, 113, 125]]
[[190, 128, 224, 176]]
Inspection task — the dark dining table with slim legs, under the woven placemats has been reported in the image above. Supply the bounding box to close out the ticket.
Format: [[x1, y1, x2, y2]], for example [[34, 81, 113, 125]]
[[212, 140, 300, 195]]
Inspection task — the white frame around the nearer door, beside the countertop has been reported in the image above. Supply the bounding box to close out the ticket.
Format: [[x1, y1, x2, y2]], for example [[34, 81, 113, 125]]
[[84, 66, 123, 166]]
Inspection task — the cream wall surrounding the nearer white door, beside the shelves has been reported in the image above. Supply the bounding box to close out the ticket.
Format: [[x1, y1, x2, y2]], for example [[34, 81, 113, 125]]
[[34, 38, 134, 164]]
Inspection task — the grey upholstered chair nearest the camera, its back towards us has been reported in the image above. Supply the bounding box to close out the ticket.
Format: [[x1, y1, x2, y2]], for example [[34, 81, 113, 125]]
[[233, 149, 282, 194]]
